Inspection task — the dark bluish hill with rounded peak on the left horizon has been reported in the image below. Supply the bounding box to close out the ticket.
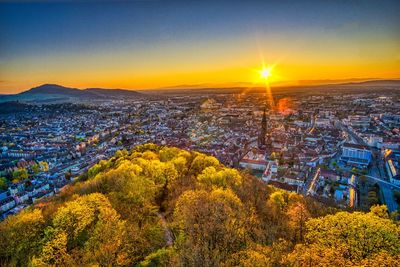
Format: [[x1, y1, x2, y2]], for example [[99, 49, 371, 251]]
[[0, 84, 145, 103]]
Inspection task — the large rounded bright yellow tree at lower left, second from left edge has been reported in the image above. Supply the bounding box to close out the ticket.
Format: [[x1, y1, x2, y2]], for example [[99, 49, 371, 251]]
[[34, 193, 125, 266]]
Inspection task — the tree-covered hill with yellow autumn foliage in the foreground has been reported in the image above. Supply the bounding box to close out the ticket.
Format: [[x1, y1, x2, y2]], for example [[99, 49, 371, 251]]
[[0, 144, 400, 266]]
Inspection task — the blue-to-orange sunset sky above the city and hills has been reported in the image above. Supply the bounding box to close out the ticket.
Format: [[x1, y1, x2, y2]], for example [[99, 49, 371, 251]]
[[0, 0, 400, 94]]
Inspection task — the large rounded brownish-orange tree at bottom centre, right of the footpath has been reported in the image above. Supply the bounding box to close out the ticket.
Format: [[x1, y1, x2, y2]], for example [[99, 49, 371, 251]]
[[174, 189, 246, 266]]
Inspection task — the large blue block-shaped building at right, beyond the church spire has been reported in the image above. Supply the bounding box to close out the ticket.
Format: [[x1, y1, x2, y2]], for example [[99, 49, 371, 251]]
[[340, 143, 372, 168]]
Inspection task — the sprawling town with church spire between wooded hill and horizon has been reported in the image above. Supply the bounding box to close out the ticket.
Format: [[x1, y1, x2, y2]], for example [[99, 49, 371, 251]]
[[0, 88, 400, 219]]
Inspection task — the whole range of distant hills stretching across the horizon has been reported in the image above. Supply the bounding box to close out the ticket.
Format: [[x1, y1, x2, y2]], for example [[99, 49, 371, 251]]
[[0, 79, 400, 104]]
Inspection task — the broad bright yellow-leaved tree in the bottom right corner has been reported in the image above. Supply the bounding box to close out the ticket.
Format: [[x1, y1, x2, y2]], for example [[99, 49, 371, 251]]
[[294, 208, 400, 262]]
